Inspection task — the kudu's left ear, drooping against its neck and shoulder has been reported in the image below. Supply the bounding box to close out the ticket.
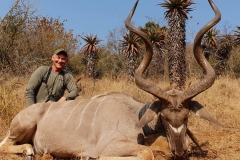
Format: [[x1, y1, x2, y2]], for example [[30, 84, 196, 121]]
[[136, 101, 161, 128]]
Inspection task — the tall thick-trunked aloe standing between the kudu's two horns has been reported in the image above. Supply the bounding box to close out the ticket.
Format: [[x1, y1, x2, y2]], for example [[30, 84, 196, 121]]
[[159, 0, 194, 89]]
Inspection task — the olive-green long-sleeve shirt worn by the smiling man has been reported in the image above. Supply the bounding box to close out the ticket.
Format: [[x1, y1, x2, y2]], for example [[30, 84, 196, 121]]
[[26, 66, 78, 106]]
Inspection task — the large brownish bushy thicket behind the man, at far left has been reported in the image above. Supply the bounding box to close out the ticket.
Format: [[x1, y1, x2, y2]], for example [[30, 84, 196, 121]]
[[0, 0, 79, 75]]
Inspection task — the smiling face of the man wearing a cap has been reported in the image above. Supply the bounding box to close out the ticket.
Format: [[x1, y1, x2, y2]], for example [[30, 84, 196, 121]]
[[52, 53, 68, 70]]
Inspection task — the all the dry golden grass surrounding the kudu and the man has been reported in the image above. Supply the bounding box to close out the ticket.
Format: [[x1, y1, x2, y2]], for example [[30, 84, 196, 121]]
[[0, 78, 240, 160]]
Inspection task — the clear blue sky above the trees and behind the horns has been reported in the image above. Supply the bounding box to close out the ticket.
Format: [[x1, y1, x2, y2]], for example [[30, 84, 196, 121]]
[[0, 0, 240, 42]]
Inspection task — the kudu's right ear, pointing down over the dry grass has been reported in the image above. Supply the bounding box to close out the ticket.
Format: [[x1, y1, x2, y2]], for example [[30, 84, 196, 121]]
[[191, 101, 222, 126]]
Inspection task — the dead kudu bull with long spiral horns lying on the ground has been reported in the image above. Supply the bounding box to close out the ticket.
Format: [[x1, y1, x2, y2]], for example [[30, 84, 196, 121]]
[[0, 0, 221, 160]]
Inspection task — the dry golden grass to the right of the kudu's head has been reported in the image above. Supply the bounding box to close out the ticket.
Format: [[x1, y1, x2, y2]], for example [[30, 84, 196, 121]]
[[189, 78, 240, 160]]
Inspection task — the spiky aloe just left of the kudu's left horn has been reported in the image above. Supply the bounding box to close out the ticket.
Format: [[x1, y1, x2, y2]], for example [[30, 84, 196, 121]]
[[121, 32, 141, 81]]
